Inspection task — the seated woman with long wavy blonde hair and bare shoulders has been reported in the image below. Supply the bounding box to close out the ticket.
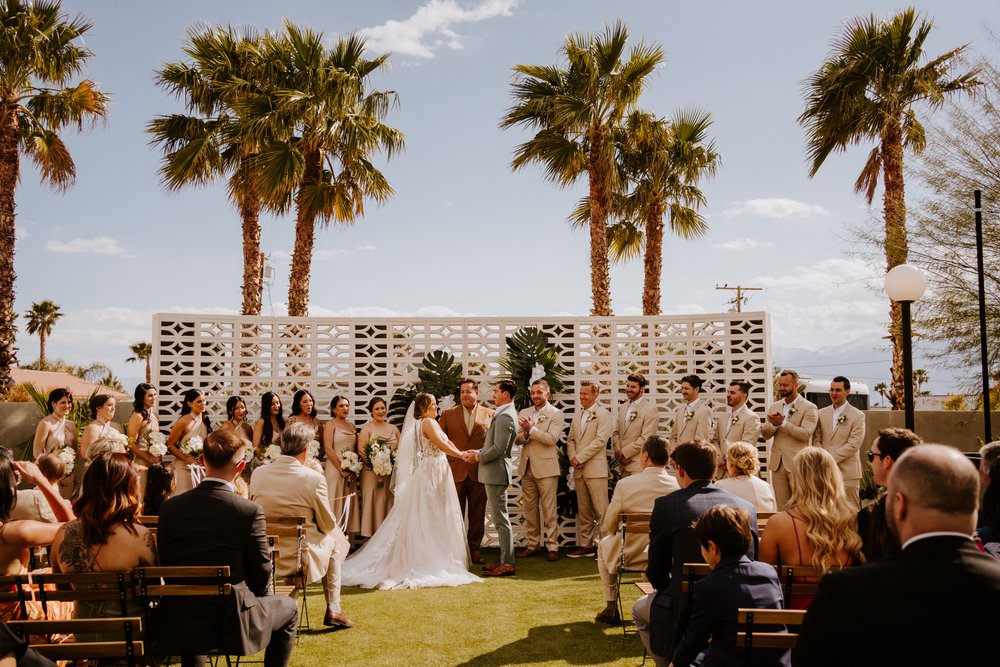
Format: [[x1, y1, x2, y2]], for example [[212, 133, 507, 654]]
[[759, 447, 864, 609]]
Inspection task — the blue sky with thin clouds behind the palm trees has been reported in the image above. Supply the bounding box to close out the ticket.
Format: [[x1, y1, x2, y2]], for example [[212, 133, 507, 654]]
[[16, 0, 1000, 392]]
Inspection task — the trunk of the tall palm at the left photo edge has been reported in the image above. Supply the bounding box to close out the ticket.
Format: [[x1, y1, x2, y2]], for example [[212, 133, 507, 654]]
[[0, 102, 20, 392]]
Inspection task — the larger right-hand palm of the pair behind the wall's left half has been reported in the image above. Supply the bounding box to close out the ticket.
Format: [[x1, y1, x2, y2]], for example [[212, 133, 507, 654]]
[[248, 21, 404, 317]]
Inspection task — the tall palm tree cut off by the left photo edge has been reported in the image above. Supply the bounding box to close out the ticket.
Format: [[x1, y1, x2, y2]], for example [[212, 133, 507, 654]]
[[0, 0, 108, 387]]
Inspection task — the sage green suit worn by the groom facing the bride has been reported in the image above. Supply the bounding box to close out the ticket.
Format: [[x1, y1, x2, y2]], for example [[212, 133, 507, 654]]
[[479, 403, 517, 565]]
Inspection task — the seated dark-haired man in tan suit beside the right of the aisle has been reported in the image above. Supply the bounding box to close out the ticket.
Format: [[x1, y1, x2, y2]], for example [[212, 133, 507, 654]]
[[594, 435, 680, 625]]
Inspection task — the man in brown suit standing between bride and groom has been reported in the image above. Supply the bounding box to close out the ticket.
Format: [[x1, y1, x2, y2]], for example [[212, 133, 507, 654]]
[[440, 379, 493, 565]]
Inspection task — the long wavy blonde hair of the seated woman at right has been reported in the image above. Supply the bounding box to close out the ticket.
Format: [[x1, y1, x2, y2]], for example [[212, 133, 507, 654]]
[[786, 447, 864, 574]]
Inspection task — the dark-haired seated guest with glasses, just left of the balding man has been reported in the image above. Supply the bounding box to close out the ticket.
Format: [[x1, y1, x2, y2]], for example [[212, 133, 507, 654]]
[[858, 428, 921, 562]]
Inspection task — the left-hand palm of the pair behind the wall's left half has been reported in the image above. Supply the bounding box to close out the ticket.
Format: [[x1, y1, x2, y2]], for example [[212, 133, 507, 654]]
[[147, 26, 264, 316]]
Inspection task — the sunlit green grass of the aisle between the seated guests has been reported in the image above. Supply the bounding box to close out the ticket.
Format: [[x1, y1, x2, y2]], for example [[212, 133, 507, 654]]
[[291, 550, 642, 667]]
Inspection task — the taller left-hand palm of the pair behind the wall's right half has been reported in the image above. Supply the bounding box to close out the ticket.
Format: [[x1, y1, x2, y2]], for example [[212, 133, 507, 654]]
[[500, 21, 663, 316]]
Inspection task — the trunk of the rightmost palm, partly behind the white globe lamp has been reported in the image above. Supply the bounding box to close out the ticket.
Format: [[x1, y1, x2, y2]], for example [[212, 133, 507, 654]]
[[882, 121, 909, 410]]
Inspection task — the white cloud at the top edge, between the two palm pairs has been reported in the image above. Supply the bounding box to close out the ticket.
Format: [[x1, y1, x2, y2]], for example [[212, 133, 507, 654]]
[[359, 0, 519, 58]]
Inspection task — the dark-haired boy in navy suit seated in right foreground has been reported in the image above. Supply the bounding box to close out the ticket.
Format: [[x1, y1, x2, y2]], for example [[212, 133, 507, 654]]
[[673, 505, 789, 667]]
